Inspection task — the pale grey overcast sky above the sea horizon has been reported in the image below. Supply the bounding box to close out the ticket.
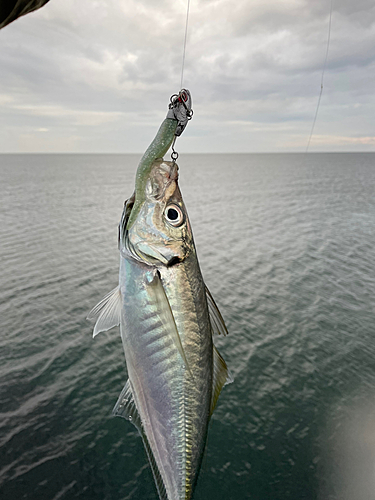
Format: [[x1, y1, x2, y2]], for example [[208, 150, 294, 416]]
[[0, 0, 375, 153]]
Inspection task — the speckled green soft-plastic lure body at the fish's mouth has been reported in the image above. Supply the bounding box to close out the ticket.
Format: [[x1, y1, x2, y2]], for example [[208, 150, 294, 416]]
[[127, 118, 178, 230]]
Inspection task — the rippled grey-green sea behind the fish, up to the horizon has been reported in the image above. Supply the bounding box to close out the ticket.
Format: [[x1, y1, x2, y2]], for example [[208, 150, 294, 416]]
[[0, 153, 375, 500]]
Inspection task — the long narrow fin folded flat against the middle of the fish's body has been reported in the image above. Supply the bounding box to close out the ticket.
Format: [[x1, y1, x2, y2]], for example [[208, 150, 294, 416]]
[[147, 272, 194, 378]]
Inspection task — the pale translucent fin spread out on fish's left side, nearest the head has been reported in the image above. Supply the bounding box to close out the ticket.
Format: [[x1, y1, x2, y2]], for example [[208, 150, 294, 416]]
[[87, 287, 121, 337]]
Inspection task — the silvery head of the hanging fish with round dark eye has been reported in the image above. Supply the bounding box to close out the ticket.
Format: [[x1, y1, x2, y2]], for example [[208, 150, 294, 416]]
[[125, 159, 194, 266]]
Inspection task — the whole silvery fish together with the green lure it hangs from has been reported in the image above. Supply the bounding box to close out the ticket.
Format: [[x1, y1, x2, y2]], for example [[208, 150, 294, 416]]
[[89, 89, 232, 500]]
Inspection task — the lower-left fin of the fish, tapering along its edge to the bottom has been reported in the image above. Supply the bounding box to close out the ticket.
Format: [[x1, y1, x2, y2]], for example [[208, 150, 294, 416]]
[[112, 379, 168, 500]]
